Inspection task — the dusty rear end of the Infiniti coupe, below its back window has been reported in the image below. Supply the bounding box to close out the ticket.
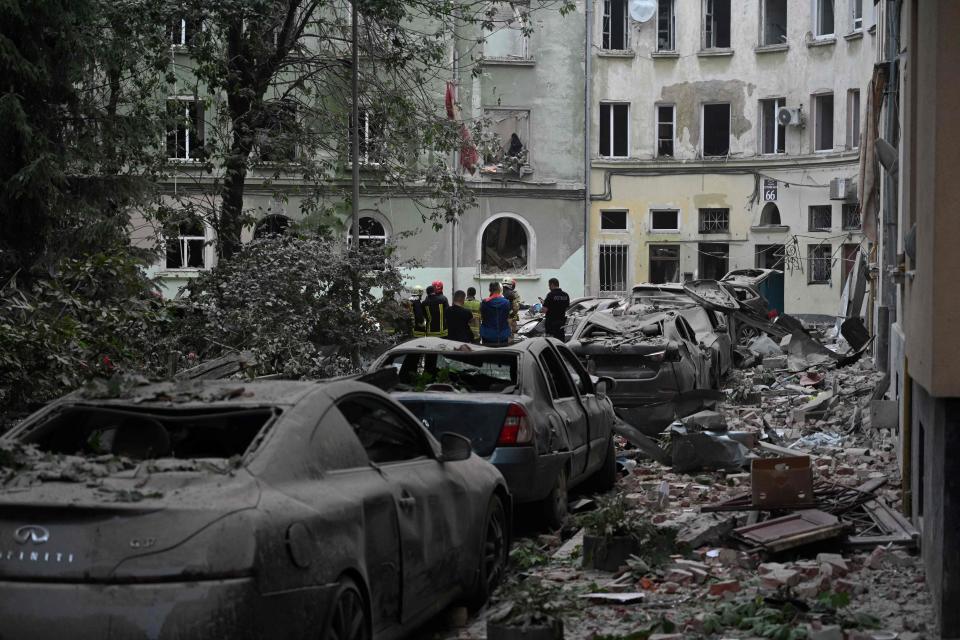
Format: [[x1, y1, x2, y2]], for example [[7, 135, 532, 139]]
[[0, 456, 260, 582]]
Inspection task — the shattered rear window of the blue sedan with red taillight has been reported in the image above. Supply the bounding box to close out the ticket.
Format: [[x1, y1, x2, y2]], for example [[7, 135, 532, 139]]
[[383, 352, 518, 392]]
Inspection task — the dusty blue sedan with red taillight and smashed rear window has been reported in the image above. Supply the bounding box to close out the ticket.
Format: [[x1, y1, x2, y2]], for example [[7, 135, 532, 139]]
[[371, 338, 617, 529]]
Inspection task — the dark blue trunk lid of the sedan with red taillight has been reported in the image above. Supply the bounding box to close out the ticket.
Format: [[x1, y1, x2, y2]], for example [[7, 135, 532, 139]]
[[393, 392, 525, 457]]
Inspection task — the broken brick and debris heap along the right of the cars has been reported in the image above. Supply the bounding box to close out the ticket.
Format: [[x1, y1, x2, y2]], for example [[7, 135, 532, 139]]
[[437, 336, 938, 640]]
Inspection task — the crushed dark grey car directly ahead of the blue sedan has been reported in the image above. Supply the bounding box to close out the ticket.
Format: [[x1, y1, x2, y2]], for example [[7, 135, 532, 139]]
[[567, 307, 721, 434]]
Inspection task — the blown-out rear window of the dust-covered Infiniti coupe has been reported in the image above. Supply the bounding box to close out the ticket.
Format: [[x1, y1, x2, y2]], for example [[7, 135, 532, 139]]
[[19, 405, 279, 460]]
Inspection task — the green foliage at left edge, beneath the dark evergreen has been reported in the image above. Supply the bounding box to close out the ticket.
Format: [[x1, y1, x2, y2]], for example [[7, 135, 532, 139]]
[[0, 251, 170, 415]]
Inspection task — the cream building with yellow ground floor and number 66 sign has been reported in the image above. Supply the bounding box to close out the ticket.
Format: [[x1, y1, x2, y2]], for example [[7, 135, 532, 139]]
[[587, 0, 877, 316]]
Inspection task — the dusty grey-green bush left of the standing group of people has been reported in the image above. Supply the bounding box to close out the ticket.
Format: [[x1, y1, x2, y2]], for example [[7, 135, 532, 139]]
[[176, 236, 410, 378]]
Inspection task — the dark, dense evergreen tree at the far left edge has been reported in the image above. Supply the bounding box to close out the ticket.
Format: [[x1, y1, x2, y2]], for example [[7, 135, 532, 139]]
[[0, 0, 171, 281]]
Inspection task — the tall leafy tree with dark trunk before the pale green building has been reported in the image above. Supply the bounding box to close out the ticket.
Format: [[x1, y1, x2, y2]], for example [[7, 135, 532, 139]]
[[161, 0, 572, 259]]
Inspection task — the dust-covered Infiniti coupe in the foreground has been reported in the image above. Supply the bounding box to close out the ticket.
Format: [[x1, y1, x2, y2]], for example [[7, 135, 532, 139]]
[[0, 381, 510, 640]]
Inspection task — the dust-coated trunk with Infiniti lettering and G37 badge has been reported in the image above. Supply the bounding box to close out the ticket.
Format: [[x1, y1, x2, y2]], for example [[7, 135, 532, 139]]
[[0, 470, 259, 582]]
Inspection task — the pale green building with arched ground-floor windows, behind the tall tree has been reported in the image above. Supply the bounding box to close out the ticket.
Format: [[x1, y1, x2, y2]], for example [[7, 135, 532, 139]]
[[139, 0, 586, 300]]
